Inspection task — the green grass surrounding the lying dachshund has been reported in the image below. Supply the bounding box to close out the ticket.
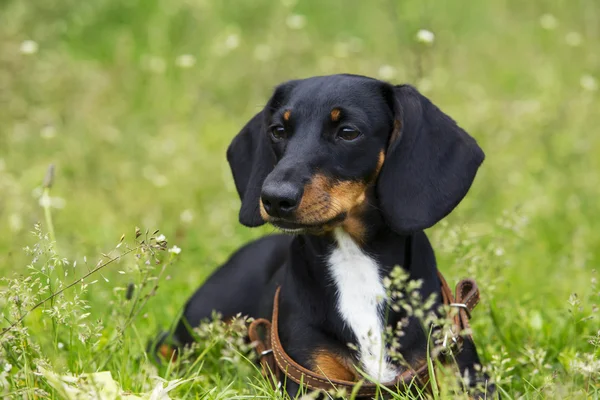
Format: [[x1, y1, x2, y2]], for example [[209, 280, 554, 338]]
[[0, 0, 600, 399]]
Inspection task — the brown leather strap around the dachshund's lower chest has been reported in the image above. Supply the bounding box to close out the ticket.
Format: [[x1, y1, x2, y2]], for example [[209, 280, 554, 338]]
[[248, 271, 479, 397]]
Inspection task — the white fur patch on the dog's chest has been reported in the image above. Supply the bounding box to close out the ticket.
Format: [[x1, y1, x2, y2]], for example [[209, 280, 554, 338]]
[[328, 228, 397, 382]]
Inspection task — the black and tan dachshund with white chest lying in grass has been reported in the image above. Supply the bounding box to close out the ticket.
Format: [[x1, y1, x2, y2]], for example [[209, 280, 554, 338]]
[[169, 75, 492, 394]]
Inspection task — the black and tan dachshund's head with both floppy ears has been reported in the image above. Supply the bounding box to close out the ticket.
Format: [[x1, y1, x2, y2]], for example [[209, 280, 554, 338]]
[[227, 75, 484, 238]]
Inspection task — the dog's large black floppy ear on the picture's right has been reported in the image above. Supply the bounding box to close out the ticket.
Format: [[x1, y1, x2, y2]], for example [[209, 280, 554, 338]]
[[377, 85, 484, 233]]
